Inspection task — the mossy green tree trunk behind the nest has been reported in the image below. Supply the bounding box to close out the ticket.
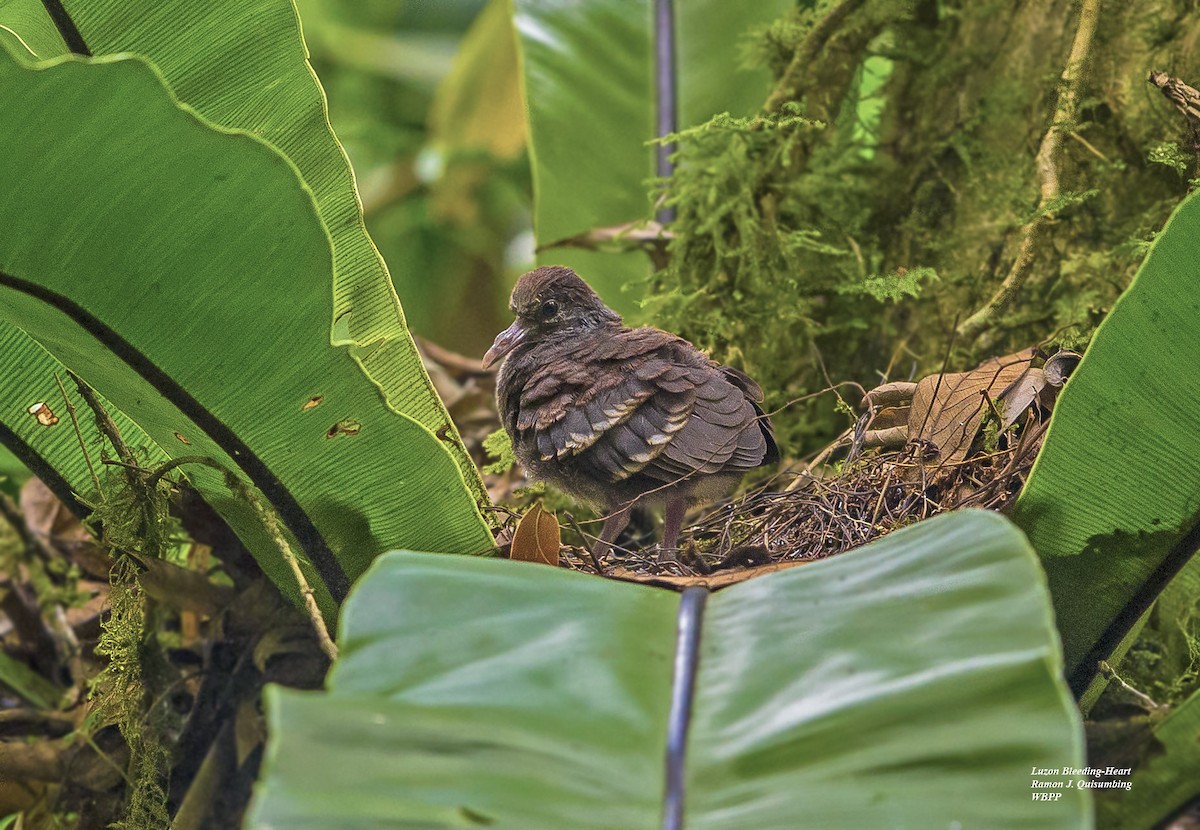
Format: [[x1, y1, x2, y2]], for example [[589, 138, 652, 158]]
[[648, 0, 1200, 456]]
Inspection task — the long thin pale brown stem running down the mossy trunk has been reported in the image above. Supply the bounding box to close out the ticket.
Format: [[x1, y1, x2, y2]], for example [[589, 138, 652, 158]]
[[959, 0, 1100, 339]]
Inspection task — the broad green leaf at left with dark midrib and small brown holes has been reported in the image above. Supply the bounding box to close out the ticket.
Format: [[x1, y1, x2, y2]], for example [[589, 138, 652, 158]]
[[0, 54, 491, 609]]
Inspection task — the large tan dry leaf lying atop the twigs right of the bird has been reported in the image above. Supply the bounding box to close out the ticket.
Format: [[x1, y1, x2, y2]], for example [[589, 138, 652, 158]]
[[908, 349, 1036, 464]]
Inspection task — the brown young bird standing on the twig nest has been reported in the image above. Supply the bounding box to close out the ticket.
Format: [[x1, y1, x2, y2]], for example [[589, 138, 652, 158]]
[[482, 265, 780, 561]]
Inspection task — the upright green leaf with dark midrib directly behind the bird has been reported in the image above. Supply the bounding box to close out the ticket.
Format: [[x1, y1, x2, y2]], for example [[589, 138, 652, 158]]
[[512, 0, 794, 313]]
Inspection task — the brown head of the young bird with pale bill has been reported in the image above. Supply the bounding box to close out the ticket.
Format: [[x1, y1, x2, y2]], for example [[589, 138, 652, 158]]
[[484, 265, 620, 368]]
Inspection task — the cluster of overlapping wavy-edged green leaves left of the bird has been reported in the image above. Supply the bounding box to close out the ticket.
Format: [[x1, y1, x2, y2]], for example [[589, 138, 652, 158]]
[[0, 1, 491, 613]]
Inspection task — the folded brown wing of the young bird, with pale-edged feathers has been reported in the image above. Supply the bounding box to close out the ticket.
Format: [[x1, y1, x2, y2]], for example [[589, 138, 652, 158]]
[[516, 330, 773, 483]]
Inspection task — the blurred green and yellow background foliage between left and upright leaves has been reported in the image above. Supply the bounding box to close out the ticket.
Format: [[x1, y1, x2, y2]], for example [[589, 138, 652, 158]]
[[296, 0, 533, 355]]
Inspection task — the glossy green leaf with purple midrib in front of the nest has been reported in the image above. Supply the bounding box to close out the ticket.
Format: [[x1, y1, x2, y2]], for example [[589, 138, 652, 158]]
[[248, 512, 1090, 830]]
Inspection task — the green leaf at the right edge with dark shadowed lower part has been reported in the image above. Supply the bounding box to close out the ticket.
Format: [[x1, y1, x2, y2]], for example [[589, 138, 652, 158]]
[[1015, 196, 1200, 687]]
